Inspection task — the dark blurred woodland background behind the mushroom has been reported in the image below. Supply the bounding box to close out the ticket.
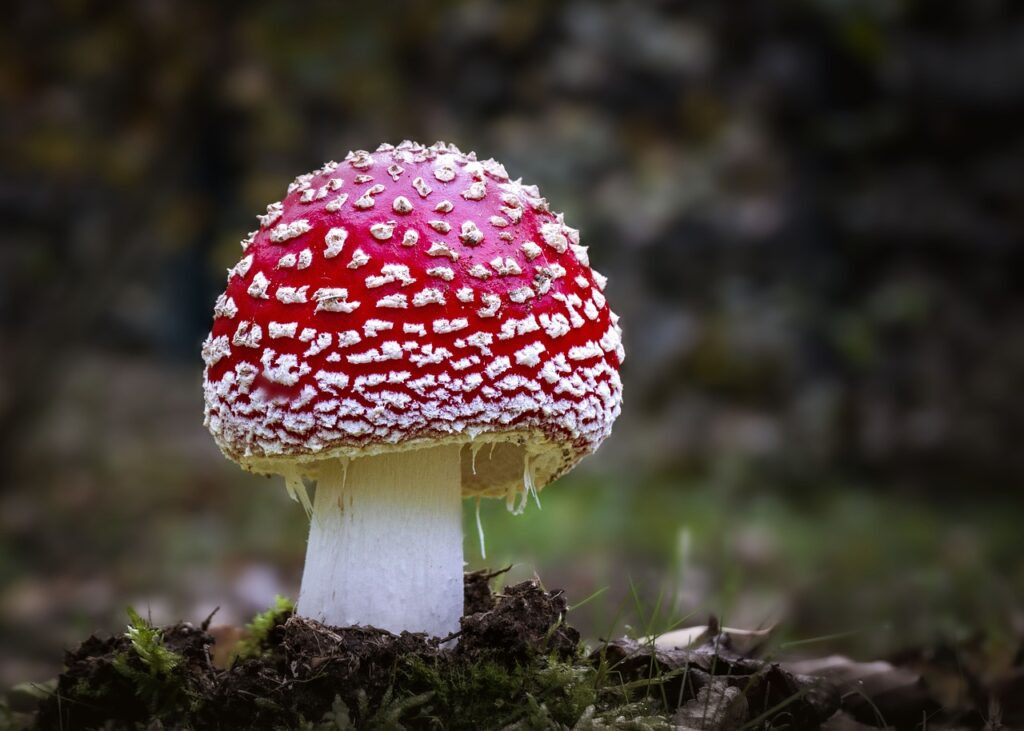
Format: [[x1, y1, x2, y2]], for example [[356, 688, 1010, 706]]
[[0, 0, 1024, 685]]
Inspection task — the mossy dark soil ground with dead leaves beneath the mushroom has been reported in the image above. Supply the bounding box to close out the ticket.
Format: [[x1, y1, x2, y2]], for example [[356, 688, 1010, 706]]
[[19, 571, 1024, 731]]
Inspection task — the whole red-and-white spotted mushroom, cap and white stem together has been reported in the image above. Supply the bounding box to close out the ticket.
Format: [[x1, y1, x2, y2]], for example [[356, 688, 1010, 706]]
[[203, 142, 624, 637]]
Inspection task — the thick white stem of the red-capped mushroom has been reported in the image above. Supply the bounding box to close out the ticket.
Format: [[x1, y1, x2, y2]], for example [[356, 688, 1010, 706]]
[[297, 445, 463, 637]]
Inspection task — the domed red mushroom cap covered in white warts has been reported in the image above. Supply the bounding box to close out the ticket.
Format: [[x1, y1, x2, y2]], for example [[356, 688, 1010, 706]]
[[203, 142, 624, 496]]
